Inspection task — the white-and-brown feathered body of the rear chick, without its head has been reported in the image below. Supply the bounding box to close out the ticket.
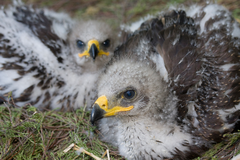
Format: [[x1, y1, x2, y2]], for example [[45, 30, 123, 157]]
[[0, 7, 101, 110]]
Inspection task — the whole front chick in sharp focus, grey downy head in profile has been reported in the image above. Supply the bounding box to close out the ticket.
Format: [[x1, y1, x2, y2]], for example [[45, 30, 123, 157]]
[[91, 4, 240, 160]]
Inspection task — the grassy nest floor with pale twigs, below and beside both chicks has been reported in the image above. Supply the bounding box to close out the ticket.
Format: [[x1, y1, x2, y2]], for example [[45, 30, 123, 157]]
[[0, 97, 240, 160]]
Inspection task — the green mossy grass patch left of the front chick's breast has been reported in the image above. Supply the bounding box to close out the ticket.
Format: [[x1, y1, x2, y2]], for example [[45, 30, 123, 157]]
[[0, 106, 120, 159]]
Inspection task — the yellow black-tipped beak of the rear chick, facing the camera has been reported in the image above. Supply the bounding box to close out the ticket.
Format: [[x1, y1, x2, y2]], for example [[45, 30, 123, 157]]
[[78, 39, 109, 60]]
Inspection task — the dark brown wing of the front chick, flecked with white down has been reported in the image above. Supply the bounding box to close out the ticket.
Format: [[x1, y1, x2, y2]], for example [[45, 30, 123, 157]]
[[151, 8, 240, 141]]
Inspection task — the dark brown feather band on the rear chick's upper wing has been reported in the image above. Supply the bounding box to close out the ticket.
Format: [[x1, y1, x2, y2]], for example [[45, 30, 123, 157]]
[[13, 6, 71, 63]]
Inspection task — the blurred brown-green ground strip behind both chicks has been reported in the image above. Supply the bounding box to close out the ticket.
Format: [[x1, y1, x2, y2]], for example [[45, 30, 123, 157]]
[[0, 0, 240, 28]]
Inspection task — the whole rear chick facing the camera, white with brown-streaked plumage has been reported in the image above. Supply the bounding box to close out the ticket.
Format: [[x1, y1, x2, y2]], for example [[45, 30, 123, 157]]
[[0, 5, 116, 109]]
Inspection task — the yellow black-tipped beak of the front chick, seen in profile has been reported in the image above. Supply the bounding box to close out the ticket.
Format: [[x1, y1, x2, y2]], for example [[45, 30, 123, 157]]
[[91, 95, 133, 123]]
